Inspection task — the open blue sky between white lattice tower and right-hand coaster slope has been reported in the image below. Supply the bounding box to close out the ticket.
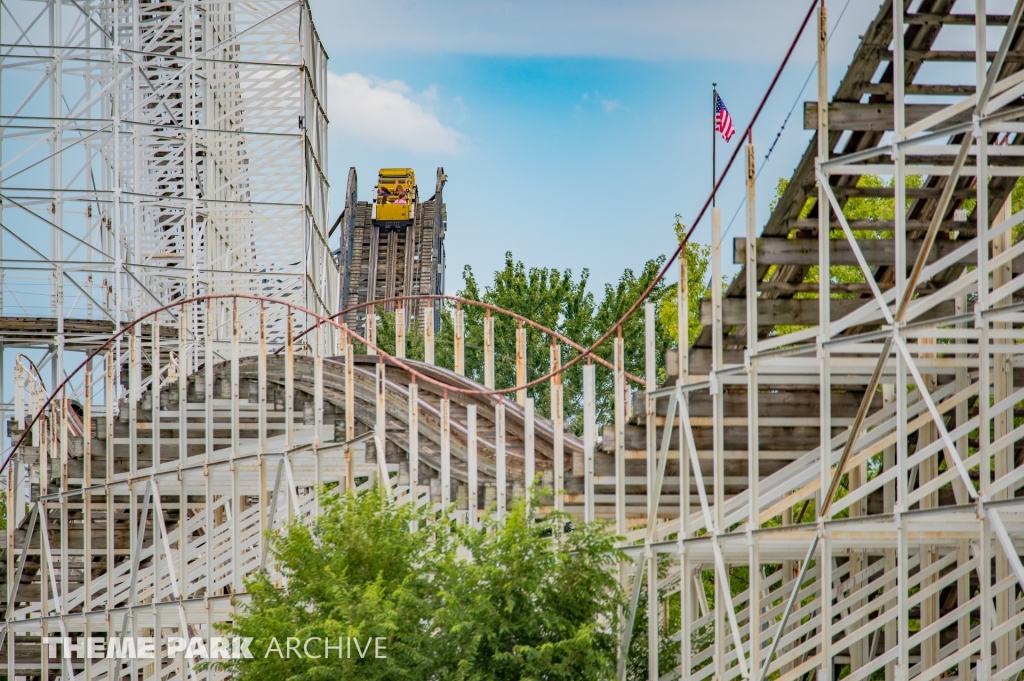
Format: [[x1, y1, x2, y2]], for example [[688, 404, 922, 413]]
[[311, 0, 878, 292]]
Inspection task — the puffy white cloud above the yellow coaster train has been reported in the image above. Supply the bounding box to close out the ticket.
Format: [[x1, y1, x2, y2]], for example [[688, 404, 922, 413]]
[[328, 73, 463, 154]]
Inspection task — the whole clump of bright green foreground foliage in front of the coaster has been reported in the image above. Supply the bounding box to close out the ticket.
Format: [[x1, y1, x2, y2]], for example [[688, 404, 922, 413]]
[[217, 488, 623, 681]]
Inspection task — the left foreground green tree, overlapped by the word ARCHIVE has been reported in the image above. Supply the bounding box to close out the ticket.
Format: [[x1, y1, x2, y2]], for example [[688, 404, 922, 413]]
[[214, 487, 457, 681]]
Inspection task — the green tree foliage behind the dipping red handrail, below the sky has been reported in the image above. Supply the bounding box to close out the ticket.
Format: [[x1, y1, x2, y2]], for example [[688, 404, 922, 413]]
[[377, 225, 711, 434]]
